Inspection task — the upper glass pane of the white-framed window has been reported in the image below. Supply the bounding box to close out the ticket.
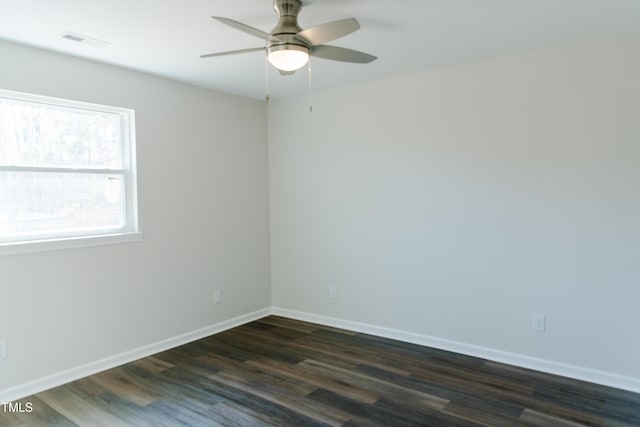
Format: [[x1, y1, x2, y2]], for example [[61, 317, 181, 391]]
[[0, 98, 122, 169]]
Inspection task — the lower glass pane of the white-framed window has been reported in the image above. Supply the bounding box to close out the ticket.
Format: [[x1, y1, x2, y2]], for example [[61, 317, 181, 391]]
[[0, 171, 125, 241]]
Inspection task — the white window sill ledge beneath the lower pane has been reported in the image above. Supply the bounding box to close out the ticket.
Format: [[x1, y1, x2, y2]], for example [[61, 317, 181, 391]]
[[0, 231, 142, 256]]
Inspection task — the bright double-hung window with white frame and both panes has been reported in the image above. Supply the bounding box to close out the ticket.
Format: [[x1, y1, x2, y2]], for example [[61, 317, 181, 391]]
[[0, 90, 140, 252]]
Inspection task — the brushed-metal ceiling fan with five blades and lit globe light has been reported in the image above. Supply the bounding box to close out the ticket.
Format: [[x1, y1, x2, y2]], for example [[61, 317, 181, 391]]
[[200, 0, 377, 75]]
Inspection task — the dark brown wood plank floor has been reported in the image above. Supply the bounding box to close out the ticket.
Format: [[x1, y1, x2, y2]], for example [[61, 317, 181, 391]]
[[0, 316, 640, 427]]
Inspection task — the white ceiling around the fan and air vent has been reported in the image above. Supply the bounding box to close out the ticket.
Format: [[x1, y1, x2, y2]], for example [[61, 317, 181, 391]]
[[0, 0, 640, 99]]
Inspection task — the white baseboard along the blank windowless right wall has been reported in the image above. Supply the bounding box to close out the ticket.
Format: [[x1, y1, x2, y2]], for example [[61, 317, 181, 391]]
[[271, 307, 640, 393]]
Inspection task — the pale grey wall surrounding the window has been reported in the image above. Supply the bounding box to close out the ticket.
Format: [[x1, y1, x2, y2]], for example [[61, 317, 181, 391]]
[[0, 42, 270, 395]]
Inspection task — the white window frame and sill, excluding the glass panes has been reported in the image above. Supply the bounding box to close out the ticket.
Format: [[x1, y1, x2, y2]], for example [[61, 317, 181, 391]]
[[0, 89, 142, 255]]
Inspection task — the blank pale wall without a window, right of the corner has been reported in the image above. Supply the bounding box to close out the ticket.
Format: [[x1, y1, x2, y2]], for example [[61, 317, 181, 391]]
[[269, 35, 640, 384]]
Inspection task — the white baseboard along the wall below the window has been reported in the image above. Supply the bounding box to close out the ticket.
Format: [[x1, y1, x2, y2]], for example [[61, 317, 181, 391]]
[[0, 308, 271, 402]]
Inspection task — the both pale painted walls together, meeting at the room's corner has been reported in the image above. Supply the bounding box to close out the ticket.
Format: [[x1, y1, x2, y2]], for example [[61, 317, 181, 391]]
[[0, 30, 640, 402]]
